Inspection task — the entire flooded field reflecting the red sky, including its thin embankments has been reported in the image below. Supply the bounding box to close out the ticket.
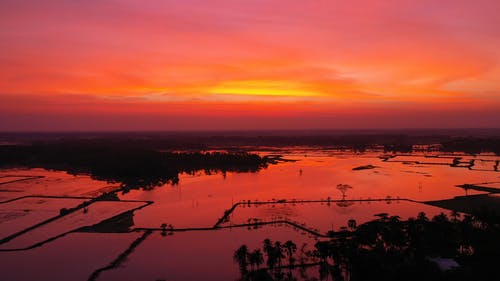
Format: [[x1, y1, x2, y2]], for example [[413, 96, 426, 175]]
[[0, 148, 500, 281]]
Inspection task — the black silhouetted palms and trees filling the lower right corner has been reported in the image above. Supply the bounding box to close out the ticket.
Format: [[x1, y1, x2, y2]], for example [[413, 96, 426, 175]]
[[233, 212, 500, 281]]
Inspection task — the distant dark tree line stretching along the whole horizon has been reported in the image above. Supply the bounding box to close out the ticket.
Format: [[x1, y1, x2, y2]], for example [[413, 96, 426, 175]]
[[0, 129, 500, 155]]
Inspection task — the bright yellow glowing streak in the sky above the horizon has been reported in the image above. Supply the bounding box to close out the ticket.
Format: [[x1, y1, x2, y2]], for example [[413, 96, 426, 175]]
[[208, 80, 324, 97]]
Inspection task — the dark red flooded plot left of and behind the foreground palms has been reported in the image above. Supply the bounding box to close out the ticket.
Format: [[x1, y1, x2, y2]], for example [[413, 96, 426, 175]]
[[98, 226, 317, 281]]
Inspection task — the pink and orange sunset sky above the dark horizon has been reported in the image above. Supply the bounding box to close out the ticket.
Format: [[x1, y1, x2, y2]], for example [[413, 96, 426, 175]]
[[0, 0, 500, 131]]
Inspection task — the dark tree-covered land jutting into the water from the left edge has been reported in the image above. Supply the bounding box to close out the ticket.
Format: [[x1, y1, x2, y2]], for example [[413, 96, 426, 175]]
[[0, 141, 276, 191]]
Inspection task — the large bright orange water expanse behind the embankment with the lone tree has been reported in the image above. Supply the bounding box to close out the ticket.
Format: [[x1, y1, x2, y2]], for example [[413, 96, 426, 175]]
[[122, 153, 500, 227]]
